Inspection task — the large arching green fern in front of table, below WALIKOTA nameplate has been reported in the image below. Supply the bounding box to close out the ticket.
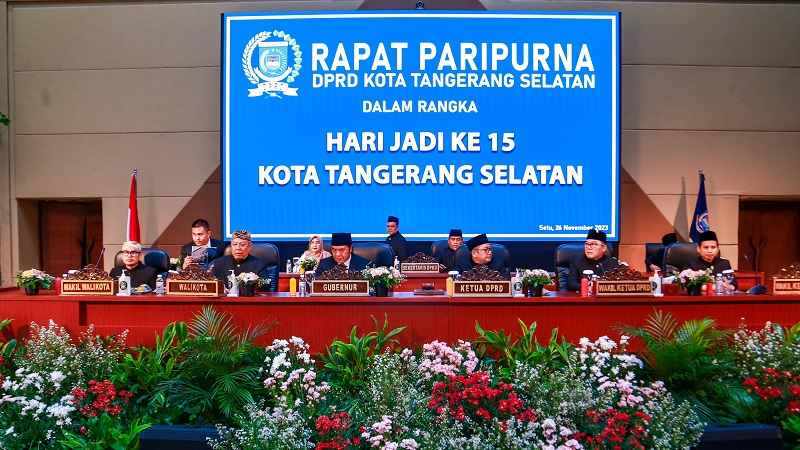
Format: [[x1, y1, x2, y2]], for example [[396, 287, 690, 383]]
[[154, 306, 277, 423]]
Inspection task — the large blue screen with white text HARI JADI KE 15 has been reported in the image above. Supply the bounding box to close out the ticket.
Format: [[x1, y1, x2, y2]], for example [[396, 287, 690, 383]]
[[222, 12, 620, 240]]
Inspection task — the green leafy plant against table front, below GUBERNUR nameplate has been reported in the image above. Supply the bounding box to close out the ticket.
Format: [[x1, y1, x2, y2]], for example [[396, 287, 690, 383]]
[[318, 316, 406, 402]]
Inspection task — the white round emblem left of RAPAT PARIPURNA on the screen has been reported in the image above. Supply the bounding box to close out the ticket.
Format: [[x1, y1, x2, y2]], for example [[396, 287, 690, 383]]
[[242, 30, 303, 98]]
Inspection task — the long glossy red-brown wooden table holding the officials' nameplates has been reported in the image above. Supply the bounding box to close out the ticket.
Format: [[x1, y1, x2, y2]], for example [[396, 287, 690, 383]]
[[0, 289, 800, 353]]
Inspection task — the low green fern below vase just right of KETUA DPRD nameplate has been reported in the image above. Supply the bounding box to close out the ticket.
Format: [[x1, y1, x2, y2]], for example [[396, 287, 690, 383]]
[[475, 318, 572, 380]]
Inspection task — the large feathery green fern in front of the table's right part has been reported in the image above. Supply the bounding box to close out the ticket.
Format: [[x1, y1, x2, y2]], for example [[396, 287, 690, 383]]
[[613, 311, 750, 422]]
